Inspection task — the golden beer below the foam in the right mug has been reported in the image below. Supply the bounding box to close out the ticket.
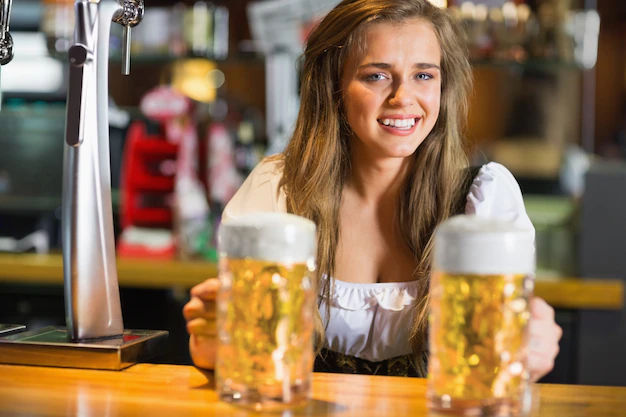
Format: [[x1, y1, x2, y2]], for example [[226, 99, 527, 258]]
[[429, 272, 530, 408]]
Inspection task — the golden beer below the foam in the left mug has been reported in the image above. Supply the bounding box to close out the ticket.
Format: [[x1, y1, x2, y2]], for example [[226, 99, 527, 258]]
[[216, 259, 315, 403]]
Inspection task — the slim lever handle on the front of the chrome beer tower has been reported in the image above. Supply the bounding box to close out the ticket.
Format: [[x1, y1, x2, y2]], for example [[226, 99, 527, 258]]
[[65, 43, 93, 146]]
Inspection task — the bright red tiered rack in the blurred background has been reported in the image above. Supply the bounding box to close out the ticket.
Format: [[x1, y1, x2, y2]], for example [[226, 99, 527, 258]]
[[120, 121, 178, 229]]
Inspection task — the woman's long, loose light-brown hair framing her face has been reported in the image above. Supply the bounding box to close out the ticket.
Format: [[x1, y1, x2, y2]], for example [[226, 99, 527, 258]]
[[281, 0, 472, 364]]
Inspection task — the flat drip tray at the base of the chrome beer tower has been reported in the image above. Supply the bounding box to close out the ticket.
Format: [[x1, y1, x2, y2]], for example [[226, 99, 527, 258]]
[[0, 326, 169, 370]]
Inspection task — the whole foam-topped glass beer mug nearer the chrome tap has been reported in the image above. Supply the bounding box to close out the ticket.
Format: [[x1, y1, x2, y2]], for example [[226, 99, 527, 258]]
[[215, 213, 317, 409]]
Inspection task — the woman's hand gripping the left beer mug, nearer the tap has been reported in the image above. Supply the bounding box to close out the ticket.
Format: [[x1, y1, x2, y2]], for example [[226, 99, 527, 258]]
[[183, 278, 220, 369]]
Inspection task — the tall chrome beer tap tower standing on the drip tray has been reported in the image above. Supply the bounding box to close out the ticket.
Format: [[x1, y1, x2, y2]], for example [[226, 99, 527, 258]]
[[62, 0, 144, 341]]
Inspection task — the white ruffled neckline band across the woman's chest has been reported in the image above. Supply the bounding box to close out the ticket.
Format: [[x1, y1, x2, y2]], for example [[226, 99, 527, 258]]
[[324, 277, 419, 311]]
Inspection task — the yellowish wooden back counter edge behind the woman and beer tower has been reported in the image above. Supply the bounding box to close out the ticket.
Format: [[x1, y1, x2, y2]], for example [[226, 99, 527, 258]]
[[0, 254, 624, 310]]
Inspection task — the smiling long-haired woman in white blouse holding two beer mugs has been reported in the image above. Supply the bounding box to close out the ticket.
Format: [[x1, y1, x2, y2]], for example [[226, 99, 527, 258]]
[[185, 0, 560, 378]]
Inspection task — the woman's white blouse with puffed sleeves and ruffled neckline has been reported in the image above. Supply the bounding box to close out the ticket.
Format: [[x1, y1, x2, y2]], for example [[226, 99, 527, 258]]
[[222, 156, 534, 361]]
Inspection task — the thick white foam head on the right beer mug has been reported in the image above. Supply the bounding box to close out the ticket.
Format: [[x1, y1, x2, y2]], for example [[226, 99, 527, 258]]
[[433, 215, 535, 275]]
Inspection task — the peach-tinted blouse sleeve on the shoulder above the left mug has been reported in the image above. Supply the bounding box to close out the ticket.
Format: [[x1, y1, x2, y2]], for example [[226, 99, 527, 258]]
[[222, 154, 286, 220]]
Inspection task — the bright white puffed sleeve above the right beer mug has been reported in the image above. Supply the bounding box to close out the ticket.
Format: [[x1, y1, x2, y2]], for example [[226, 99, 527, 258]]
[[465, 162, 533, 228]]
